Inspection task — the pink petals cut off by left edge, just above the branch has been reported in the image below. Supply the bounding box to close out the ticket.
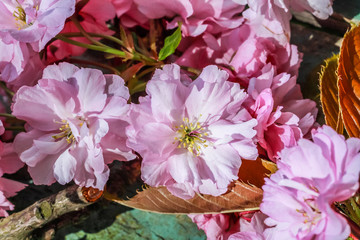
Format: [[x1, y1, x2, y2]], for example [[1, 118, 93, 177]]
[[0, 143, 26, 217]]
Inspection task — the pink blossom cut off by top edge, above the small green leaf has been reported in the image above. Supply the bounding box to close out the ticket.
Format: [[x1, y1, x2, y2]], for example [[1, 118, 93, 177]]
[[130, 0, 246, 36]]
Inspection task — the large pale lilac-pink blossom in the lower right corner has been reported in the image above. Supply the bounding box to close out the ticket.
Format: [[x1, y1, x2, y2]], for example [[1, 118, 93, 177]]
[[260, 126, 360, 240]]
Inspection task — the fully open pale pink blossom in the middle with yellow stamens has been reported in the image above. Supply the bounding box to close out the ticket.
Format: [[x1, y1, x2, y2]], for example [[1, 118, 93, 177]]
[[127, 64, 257, 198]]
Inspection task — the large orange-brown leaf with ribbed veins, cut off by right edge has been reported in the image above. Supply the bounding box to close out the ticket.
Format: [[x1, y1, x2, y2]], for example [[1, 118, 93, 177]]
[[338, 26, 360, 137]]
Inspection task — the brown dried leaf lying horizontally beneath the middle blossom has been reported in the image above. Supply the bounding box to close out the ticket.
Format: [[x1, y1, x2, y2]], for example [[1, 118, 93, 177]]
[[112, 181, 262, 214]]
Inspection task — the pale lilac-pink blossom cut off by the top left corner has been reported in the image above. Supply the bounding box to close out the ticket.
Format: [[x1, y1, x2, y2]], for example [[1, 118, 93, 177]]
[[0, 0, 75, 52]]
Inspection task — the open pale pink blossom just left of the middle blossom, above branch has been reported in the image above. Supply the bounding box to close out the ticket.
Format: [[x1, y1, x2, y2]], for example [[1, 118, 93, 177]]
[[12, 63, 134, 189]]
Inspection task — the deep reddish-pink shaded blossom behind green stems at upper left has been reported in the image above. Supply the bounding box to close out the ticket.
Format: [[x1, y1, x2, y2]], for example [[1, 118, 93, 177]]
[[47, 0, 115, 62]]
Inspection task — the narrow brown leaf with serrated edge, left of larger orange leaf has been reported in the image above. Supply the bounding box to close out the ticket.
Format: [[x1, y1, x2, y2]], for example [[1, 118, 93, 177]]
[[320, 55, 344, 134]]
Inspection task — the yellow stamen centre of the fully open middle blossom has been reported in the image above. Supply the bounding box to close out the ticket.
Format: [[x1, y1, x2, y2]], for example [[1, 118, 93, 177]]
[[174, 118, 208, 156]]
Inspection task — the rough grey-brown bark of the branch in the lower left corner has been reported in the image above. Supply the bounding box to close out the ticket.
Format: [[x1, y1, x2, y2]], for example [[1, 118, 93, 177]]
[[0, 186, 92, 240]]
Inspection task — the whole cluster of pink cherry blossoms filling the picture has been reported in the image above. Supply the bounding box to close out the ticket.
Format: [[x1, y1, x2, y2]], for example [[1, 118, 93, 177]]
[[0, 0, 360, 240]]
